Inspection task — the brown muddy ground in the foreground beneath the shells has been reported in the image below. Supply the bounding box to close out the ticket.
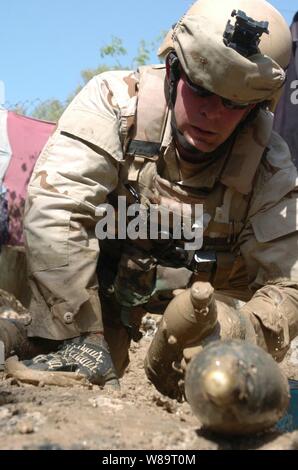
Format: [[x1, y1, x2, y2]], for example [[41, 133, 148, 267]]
[[0, 326, 298, 450]]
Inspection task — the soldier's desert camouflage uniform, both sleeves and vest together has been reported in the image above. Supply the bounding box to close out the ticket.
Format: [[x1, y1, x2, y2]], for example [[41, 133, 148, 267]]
[[25, 67, 298, 370]]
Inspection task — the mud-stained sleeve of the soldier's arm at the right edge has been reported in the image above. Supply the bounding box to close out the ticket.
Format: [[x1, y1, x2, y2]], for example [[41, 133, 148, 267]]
[[239, 136, 298, 359]]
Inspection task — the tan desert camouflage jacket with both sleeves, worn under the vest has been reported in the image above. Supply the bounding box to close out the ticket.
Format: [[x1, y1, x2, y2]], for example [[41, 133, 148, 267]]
[[25, 65, 298, 343]]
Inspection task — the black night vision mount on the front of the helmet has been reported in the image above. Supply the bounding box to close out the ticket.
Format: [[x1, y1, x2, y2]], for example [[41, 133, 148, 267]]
[[223, 10, 269, 57]]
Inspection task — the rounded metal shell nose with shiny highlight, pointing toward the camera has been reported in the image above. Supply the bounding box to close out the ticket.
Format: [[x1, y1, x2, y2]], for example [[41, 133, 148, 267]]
[[185, 340, 289, 435]]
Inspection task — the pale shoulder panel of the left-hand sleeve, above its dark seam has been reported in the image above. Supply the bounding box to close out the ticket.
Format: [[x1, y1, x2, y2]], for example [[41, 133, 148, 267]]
[[58, 71, 138, 161]]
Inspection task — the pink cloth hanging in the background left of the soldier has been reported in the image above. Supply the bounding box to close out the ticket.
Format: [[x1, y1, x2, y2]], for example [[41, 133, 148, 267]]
[[3, 112, 55, 245]]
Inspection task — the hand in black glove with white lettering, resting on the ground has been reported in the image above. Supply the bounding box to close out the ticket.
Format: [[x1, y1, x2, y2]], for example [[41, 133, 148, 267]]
[[23, 334, 120, 389]]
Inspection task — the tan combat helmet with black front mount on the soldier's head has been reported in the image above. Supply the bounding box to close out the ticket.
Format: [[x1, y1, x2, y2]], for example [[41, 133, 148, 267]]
[[158, 0, 292, 110]]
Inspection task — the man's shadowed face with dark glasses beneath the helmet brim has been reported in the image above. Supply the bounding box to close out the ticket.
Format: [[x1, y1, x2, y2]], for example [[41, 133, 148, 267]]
[[174, 72, 254, 153]]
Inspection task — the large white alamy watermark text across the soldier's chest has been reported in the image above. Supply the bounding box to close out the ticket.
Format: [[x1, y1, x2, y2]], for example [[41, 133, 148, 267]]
[[95, 196, 204, 251]]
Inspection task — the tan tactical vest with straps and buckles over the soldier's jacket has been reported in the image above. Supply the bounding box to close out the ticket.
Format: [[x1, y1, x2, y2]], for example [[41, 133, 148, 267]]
[[96, 66, 272, 309]]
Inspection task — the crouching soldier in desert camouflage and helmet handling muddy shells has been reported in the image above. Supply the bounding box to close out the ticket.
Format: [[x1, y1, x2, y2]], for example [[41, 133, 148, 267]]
[[21, 0, 298, 396]]
